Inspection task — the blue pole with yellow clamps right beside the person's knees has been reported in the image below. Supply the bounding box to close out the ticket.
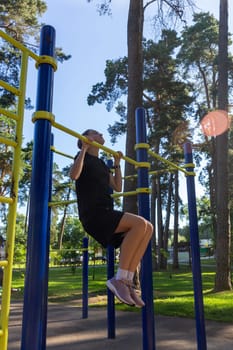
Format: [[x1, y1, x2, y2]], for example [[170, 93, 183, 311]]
[[136, 107, 155, 350]]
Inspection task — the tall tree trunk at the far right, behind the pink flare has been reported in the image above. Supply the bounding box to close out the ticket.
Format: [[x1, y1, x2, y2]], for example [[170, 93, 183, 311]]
[[215, 0, 232, 291]]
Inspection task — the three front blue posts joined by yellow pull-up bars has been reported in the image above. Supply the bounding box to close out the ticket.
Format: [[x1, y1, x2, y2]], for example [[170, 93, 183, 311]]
[[0, 26, 206, 350]]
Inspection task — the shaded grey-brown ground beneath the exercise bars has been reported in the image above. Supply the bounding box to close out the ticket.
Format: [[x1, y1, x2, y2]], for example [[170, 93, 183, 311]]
[[8, 302, 233, 350]]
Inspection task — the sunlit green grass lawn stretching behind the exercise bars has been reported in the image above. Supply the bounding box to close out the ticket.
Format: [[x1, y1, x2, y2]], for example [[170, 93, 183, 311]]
[[12, 261, 233, 322]]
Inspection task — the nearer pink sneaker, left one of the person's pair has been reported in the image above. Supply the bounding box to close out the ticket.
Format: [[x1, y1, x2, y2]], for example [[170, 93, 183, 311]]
[[107, 277, 135, 305]]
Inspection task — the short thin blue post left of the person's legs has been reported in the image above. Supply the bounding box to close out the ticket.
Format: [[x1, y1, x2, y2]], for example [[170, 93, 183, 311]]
[[82, 237, 88, 318]]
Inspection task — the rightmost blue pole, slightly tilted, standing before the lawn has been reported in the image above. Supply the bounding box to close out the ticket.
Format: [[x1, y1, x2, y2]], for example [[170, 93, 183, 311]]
[[184, 143, 207, 350]]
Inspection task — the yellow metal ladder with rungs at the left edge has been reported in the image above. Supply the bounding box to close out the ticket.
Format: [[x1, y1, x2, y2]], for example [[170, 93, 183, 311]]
[[0, 30, 30, 350]]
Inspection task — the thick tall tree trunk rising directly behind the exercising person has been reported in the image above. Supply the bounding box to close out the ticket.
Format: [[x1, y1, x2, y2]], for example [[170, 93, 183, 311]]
[[124, 0, 144, 213]]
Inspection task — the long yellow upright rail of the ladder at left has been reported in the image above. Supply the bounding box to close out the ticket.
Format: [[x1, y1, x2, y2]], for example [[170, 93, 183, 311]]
[[0, 50, 28, 350]]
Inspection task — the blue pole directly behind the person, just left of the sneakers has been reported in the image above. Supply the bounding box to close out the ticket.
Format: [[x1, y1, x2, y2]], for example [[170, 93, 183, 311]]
[[107, 159, 116, 339]]
